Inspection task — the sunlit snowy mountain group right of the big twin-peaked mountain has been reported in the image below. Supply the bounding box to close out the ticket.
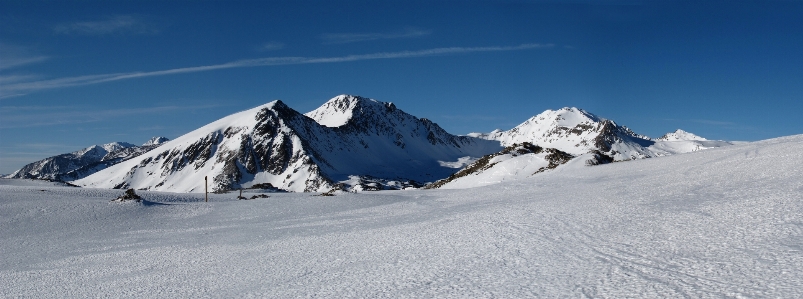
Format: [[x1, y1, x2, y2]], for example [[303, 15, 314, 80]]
[[440, 108, 732, 188]]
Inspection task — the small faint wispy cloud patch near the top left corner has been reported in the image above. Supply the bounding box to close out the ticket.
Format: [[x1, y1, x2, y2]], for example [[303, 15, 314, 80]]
[[53, 16, 158, 35]]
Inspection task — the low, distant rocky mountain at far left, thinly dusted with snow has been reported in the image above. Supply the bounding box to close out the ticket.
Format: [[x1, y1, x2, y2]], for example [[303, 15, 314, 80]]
[[6, 137, 168, 181]]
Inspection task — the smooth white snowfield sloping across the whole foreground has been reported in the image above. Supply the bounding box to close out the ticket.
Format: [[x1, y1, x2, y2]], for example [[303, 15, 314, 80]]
[[0, 135, 803, 298]]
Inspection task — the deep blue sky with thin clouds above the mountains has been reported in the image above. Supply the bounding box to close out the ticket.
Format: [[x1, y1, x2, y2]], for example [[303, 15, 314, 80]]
[[0, 0, 803, 174]]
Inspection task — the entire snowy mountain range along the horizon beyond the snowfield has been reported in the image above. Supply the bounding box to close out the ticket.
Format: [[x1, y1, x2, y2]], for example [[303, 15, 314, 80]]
[[7, 95, 732, 192]]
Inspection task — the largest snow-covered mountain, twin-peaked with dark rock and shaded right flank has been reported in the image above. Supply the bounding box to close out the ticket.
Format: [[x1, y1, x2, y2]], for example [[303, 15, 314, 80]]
[[73, 95, 502, 192]]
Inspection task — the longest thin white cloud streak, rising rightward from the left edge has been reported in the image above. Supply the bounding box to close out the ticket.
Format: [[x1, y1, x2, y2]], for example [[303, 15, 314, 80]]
[[0, 44, 554, 97]]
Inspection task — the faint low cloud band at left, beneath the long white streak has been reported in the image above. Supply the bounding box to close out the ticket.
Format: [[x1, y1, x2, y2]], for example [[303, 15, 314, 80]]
[[0, 105, 219, 129]]
